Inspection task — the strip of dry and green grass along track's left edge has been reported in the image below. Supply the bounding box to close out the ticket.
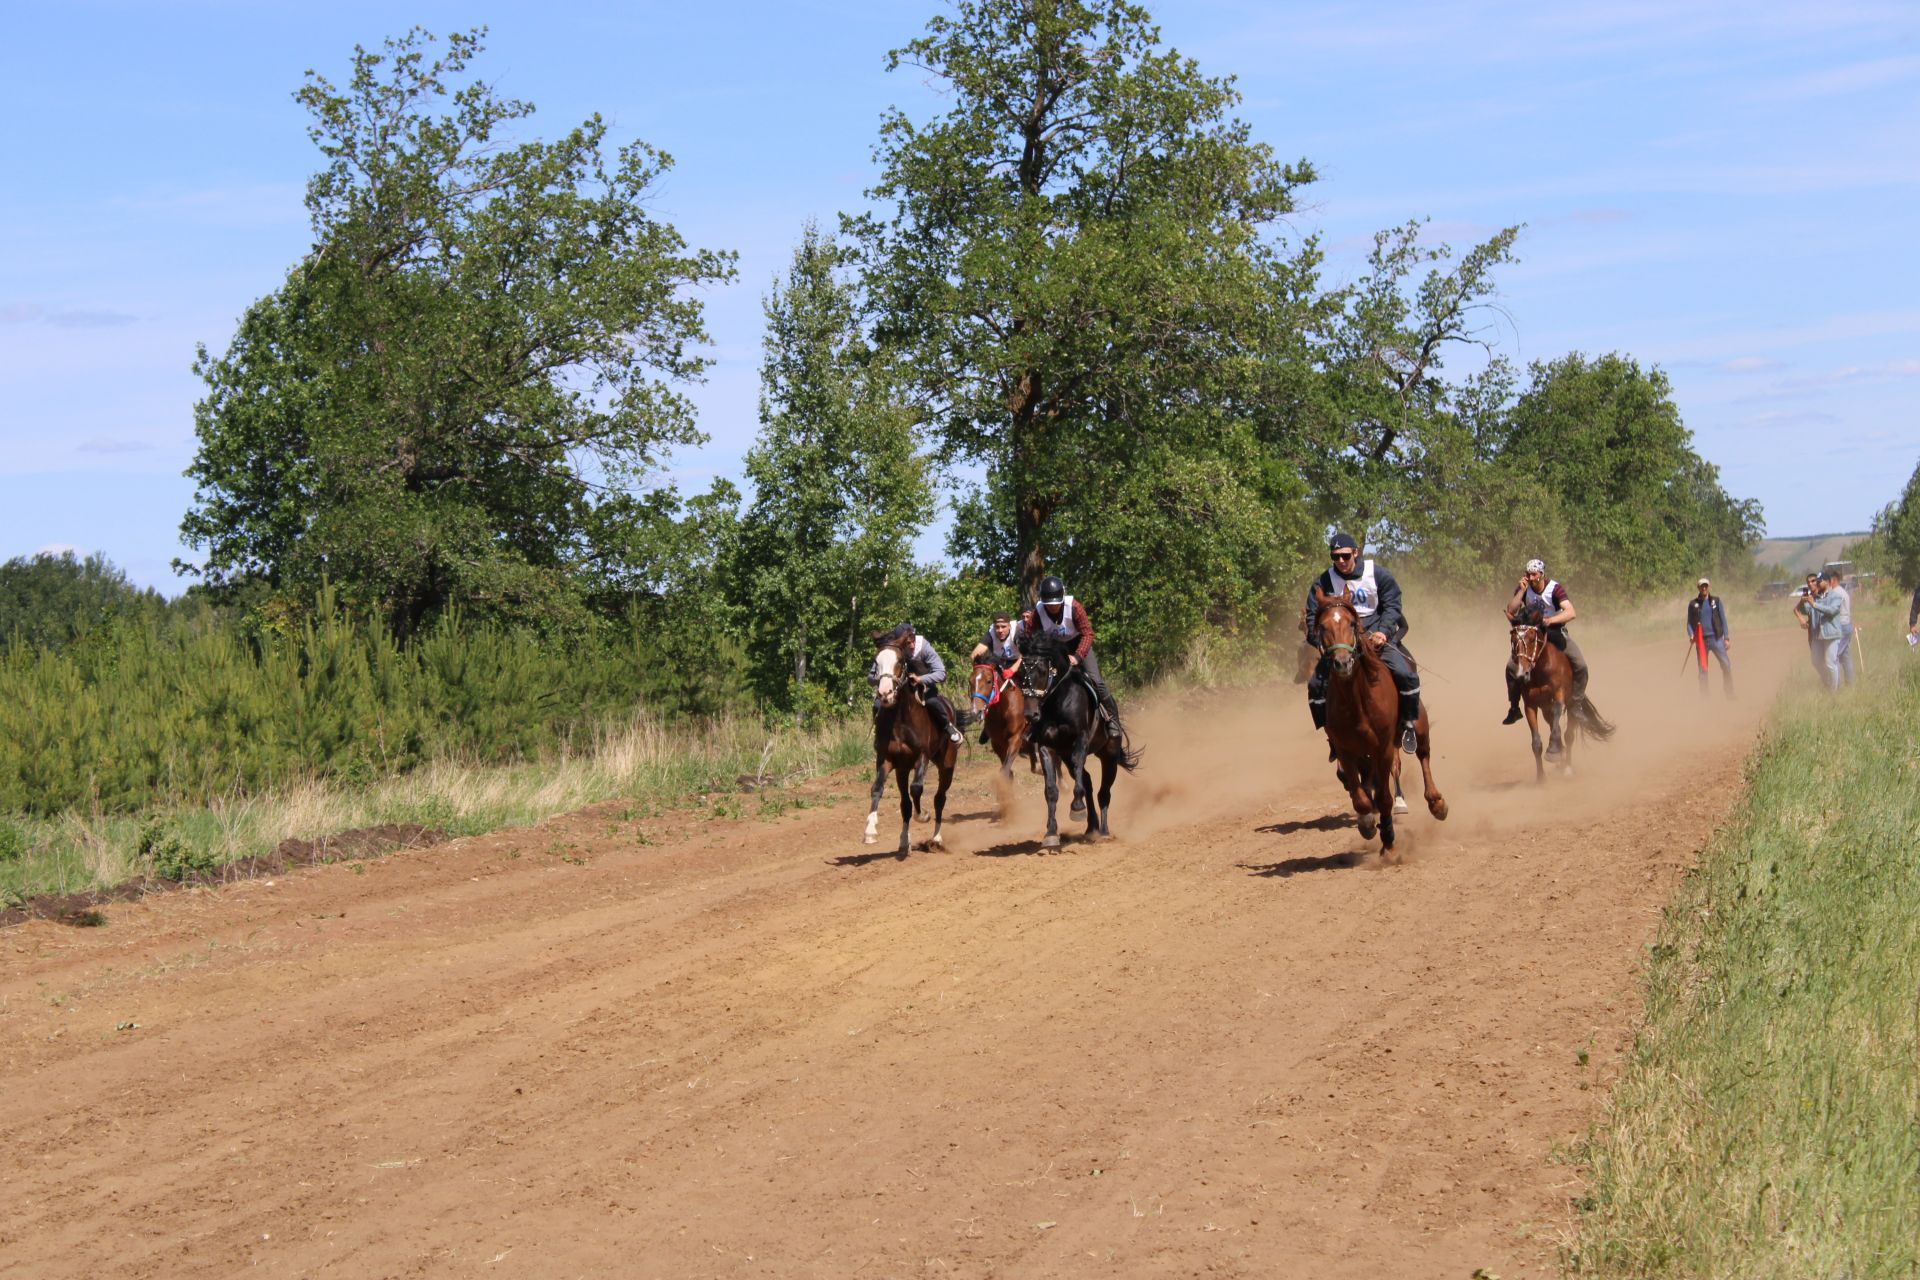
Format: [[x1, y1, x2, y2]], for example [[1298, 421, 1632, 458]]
[[0, 716, 872, 906]]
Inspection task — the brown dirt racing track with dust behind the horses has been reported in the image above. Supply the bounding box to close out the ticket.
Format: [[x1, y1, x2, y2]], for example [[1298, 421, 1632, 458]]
[[0, 633, 1801, 1280]]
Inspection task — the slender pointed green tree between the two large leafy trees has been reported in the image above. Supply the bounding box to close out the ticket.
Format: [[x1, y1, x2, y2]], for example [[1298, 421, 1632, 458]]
[[733, 223, 933, 710]]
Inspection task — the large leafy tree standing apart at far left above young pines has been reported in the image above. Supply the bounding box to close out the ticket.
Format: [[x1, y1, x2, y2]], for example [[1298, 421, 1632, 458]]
[[182, 29, 732, 633]]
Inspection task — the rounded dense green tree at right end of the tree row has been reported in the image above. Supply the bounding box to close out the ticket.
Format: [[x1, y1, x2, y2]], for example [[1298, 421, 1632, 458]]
[[1494, 353, 1763, 589]]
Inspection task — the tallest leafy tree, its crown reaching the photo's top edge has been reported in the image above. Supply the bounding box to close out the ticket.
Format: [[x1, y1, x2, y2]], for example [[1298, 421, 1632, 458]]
[[851, 0, 1313, 614]]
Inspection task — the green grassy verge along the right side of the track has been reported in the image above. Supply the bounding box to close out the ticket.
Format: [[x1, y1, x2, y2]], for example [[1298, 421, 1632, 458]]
[[1565, 610, 1920, 1280]]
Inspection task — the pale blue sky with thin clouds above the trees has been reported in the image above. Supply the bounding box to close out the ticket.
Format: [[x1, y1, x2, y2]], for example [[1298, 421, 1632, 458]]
[[0, 0, 1920, 591]]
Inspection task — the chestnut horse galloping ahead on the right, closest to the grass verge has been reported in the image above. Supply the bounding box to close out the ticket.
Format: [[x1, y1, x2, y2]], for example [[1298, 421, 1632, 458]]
[[1313, 587, 1448, 862]]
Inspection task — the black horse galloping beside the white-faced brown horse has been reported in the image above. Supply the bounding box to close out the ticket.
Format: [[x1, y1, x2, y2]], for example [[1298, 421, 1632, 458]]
[[1020, 633, 1140, 848]]
